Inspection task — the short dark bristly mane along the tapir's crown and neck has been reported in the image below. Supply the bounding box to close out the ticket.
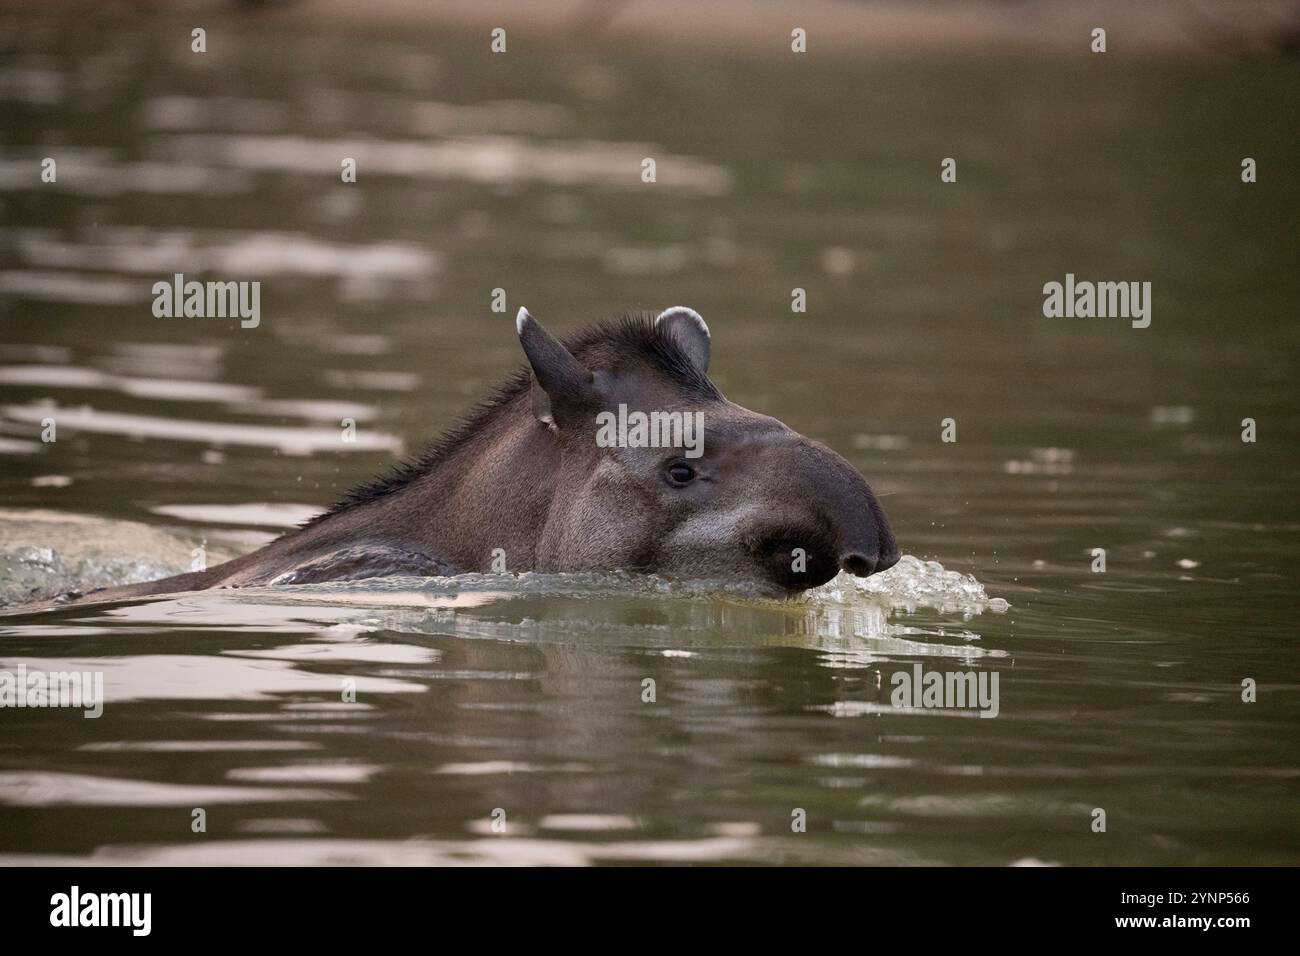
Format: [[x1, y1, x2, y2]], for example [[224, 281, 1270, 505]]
[[300, 312, 722, 528]]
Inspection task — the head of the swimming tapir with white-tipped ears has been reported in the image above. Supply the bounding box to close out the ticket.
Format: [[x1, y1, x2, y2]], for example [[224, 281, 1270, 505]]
[[517, 307, 898, 593]]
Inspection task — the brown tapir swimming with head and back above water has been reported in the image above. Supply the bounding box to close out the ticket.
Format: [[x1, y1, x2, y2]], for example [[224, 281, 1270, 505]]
[[76, 307, 898, 601]]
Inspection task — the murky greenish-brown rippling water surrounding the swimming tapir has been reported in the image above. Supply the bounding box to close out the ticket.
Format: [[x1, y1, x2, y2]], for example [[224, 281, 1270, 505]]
[[0, 20, 1300, 864]]
